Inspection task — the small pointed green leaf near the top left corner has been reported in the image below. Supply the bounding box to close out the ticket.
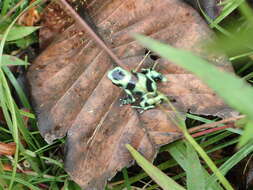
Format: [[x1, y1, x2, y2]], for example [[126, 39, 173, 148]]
[[0, 26, 40, 41]]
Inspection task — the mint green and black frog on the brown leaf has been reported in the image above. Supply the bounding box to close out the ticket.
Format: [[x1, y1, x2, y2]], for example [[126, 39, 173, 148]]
[[107, 66, 167, 113]]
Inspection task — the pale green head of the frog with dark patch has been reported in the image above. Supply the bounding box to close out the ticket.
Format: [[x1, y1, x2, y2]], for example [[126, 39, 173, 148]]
[[107, 67, 129, 86]]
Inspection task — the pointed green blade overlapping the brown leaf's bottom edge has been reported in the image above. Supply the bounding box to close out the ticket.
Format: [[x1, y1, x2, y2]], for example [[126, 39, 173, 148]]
[[126, 144, 185, 190]]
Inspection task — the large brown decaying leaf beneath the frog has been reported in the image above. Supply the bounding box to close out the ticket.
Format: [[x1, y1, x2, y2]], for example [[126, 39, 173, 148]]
[[28, 0, 236, 189]]
